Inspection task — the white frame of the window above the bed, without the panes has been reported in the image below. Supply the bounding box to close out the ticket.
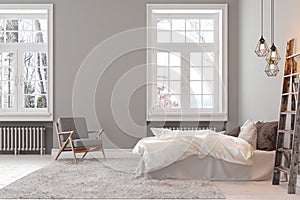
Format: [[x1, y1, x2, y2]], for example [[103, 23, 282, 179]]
[[146, 4, 228, 121]]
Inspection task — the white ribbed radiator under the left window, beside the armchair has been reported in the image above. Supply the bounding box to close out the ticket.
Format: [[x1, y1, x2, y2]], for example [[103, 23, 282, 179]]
[[0, 126, 46, 155]]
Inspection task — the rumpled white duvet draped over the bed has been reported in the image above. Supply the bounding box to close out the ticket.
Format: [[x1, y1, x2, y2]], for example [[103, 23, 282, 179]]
[[133, 130, 253, 172]]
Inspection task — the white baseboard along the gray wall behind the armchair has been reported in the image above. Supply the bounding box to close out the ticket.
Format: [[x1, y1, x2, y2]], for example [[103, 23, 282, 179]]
[[51, 149, 138, 158]]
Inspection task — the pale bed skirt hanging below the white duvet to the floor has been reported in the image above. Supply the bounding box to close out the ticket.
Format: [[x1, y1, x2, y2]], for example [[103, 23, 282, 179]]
[[137, 150, 275, 181]]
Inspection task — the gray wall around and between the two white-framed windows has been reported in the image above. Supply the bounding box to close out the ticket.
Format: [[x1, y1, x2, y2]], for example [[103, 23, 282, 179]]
[[0, 0, 238, 148]]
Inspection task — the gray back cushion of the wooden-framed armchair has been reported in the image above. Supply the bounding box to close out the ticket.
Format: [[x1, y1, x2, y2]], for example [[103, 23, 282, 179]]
[[57, 117, 88, 142]]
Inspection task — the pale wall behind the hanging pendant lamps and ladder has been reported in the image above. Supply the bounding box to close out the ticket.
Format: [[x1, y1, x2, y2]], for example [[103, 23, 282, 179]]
[[238, 0, 300, 124]]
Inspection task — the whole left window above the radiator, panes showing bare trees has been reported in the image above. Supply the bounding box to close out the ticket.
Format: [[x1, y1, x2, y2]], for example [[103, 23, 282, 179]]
[[0, 4, 53, 121]]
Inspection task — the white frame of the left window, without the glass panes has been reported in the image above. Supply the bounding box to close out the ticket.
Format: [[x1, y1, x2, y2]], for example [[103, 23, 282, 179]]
[[0, 4, 53, 121]]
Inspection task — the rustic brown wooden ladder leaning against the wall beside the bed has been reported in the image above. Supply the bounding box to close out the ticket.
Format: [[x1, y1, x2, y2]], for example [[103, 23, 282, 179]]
[[272, 39, 300, 194]]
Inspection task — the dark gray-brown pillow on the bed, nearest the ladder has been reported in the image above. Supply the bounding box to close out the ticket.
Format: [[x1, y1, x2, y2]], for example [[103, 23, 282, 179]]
[[256, 121, 278, 151]]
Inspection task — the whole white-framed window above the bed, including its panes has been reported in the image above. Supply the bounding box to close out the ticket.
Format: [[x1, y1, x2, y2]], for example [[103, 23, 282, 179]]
[[147, 4, 227, 121]]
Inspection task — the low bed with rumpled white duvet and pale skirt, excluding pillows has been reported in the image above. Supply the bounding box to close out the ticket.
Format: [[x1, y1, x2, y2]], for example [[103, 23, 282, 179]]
[[133, 120, 275, 181]]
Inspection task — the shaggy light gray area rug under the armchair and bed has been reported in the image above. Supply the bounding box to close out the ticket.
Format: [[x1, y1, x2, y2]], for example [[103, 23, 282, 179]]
[[0, 159, 225, 199]]
